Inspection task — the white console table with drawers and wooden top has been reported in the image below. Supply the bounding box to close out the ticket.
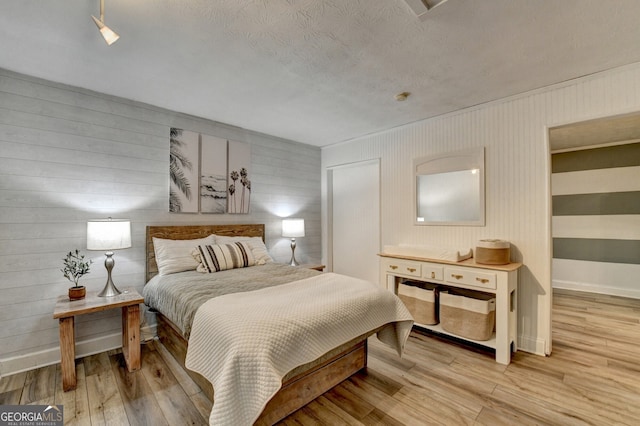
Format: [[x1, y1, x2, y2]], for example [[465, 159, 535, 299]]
[[380, 253, 522, 364]]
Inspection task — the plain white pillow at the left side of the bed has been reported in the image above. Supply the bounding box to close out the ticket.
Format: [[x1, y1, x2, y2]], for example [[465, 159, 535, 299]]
[[153, 235, 216, 275]]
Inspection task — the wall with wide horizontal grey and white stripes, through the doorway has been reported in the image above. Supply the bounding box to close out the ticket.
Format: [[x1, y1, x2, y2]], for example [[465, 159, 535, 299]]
[[551, 142, 640, 297]]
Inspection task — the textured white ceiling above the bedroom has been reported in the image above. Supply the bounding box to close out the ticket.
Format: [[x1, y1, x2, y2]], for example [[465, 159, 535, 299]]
[[0, 0, 640, 146]]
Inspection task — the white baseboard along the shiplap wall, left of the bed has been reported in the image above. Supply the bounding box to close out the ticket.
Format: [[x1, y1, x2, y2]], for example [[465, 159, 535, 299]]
[[0, 324, 156, 377]]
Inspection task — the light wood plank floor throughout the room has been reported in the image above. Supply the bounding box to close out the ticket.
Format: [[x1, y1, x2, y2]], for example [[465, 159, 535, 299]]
[[0, 291, 640, 425]]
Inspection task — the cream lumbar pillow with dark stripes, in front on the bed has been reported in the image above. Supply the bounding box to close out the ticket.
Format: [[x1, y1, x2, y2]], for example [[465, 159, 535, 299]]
[[192, 241, 256, 272]]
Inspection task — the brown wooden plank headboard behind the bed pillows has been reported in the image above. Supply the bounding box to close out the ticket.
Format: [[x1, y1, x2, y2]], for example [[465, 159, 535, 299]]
[[145, 223, 264, 281]]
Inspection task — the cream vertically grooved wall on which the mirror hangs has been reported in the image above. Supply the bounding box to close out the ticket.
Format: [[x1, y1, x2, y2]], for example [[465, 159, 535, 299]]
[[322, 60, 640, 354]]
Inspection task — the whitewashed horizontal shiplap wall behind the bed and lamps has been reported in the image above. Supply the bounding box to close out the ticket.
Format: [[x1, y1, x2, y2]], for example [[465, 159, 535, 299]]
[[0, 69, 321, 375]]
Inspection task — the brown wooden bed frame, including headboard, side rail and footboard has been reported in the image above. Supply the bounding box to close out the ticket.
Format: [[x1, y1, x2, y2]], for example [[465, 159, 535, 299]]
[[146, 224, 368, 425]]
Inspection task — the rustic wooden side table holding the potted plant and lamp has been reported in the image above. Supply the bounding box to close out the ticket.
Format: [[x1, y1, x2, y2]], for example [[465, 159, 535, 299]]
[[53, 288, 144, 392]]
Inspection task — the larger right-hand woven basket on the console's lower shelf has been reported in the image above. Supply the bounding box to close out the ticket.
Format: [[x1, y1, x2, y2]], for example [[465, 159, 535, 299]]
[[440, 290, 496, 340]]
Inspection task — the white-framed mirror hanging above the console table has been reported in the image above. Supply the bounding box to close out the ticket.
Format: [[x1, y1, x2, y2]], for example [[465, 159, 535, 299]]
[[413, 148, 485, 226]]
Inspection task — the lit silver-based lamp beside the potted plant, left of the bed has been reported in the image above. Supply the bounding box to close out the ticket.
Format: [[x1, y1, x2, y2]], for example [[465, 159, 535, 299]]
[[87, 218, 131, 297]]
